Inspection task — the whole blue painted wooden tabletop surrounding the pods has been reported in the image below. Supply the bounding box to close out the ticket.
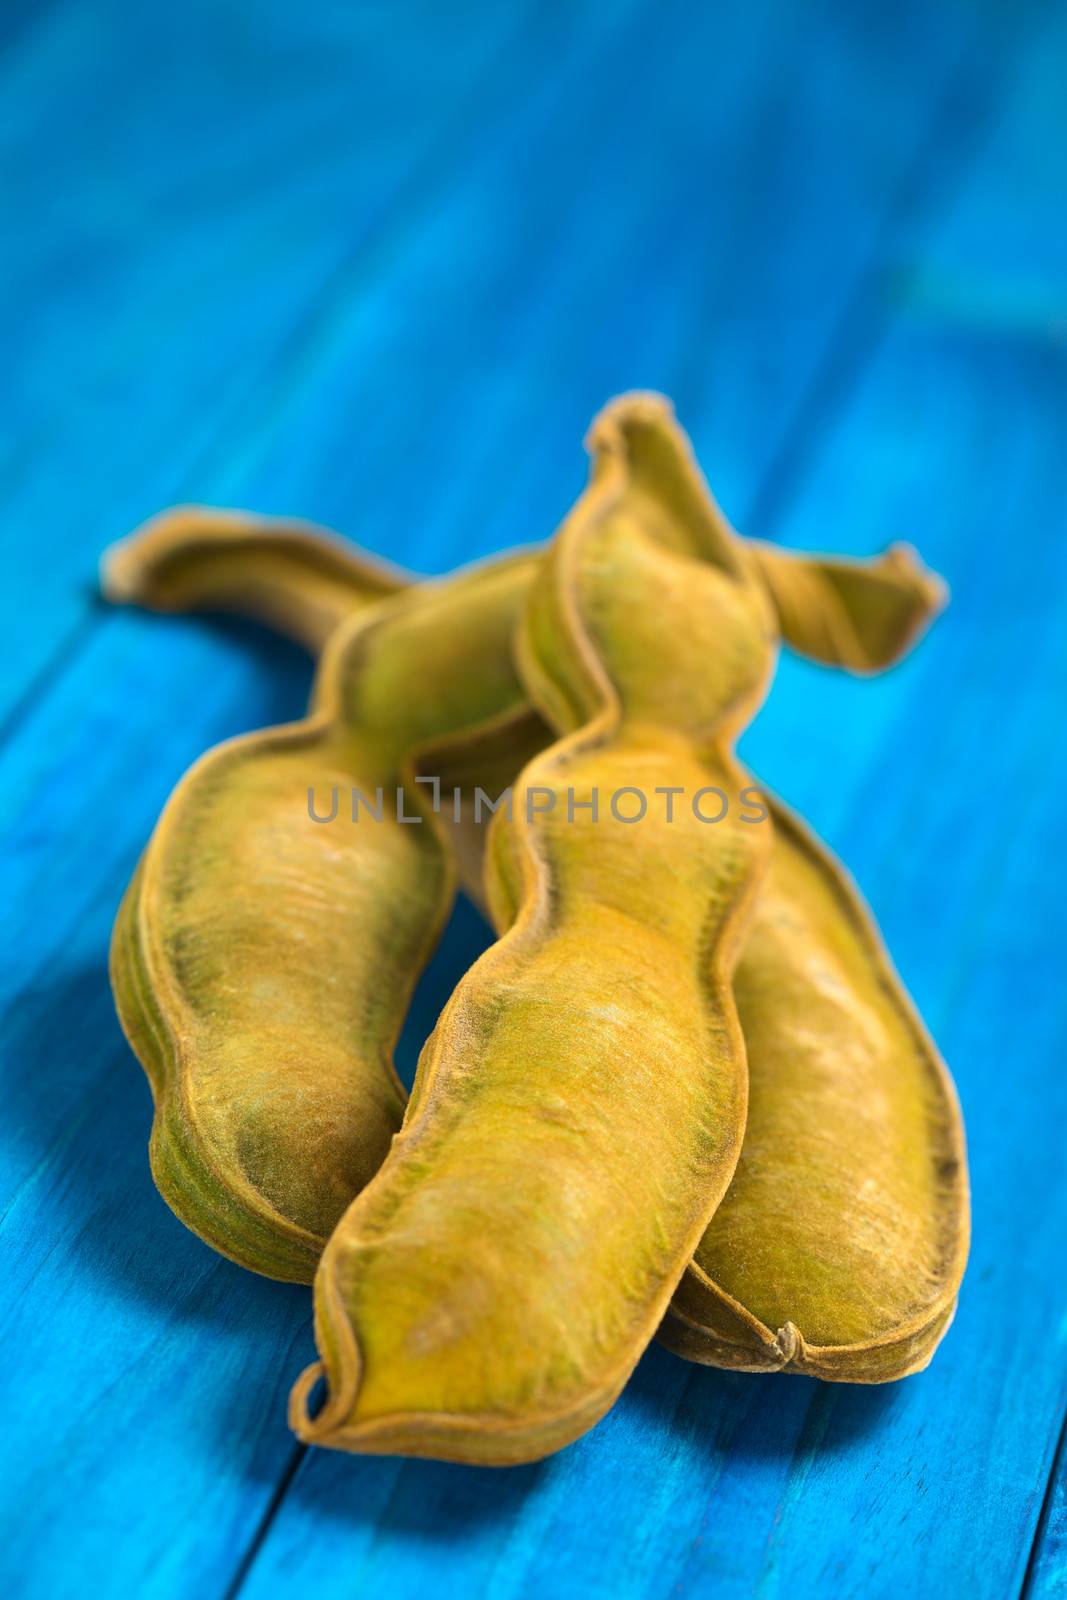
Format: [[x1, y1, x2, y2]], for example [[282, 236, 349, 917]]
[[0, 0, 1067, 1600]]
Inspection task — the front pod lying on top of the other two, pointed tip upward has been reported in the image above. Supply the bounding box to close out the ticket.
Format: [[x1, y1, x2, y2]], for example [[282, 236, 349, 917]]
[[291, 398, 773, 1464]]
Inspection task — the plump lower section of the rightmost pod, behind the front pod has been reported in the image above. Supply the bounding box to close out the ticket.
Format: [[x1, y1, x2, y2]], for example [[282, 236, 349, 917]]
[[661, 800, 969, 1382]]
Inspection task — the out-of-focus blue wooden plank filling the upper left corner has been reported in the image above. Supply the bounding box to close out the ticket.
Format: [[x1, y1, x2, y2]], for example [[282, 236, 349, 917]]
[[0, 0, 614, 714]]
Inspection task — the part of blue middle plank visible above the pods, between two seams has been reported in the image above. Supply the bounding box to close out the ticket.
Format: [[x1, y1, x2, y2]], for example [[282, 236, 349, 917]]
[[217, 3, 998, 568]]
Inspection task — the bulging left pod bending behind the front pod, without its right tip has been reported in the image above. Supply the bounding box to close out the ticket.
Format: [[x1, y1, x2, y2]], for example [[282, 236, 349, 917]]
[[112, 562, 528, 1282]]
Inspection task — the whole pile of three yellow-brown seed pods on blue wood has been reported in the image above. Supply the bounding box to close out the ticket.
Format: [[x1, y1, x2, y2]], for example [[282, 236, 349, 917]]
[[104, 395, 968, 1464]]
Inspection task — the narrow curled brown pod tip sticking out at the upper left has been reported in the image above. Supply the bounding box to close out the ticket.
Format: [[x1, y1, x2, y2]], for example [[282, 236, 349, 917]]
[[101, 506, 413, 651]]
